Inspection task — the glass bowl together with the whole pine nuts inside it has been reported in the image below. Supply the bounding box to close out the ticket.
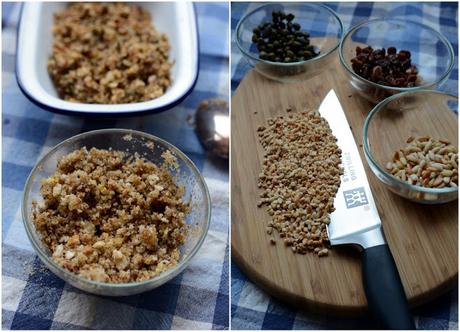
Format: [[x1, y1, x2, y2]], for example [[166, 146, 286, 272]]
[[363, 90, 458, 204]]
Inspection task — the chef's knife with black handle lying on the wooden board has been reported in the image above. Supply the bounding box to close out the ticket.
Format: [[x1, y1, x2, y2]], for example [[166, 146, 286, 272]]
[[319, 90, 415, 330]]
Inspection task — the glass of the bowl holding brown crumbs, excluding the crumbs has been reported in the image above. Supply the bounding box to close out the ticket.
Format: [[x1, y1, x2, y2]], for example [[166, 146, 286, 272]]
[[22, 129, 211, 296]]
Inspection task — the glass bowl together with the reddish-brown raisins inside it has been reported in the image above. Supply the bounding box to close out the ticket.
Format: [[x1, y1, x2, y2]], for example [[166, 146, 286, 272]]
[[339, 18, 454, 104]]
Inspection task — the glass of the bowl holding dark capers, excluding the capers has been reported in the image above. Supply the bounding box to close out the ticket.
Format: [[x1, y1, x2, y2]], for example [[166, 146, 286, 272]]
[[236, 2, 343, 82]]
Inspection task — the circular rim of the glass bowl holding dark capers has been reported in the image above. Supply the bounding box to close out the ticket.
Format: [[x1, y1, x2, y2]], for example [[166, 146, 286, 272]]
[[235, 2, 344, 67]]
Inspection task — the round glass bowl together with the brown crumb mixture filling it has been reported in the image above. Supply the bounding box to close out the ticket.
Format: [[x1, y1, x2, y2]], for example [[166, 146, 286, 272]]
[[21, 129, 211, 296]]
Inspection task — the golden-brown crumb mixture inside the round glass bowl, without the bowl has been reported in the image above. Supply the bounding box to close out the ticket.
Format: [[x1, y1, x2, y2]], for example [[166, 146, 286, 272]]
[[33, 148, 190, 283]]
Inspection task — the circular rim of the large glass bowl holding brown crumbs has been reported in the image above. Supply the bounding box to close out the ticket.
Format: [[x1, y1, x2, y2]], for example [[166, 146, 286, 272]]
[[21, 128, 211, 290]]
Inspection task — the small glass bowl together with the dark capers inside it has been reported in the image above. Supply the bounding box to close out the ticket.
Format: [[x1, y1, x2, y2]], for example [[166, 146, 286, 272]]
[[236, 3, 343, 82]]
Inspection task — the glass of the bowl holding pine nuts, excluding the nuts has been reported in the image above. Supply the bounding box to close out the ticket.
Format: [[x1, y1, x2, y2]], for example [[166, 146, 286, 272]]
[[363, 90, 458, 204]]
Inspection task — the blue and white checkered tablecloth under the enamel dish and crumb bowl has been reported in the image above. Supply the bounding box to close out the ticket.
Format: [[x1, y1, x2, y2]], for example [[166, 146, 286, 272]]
[[2, 3, 229, 330]]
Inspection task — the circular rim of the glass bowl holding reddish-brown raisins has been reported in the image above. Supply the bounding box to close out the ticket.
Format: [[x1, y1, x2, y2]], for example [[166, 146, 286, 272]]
[[339, 17, 455, 92]]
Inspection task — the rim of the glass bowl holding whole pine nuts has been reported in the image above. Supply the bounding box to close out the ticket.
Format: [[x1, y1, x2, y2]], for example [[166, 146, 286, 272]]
[[362, 90, 458, 194]]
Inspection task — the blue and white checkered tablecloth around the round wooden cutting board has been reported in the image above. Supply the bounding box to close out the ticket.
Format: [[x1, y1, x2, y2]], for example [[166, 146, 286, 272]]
[[231, 2, 458, 330]]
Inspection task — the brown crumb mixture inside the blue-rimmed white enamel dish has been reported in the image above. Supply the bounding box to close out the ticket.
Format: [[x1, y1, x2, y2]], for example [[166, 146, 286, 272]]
[[48, 2, 171, 104]]
